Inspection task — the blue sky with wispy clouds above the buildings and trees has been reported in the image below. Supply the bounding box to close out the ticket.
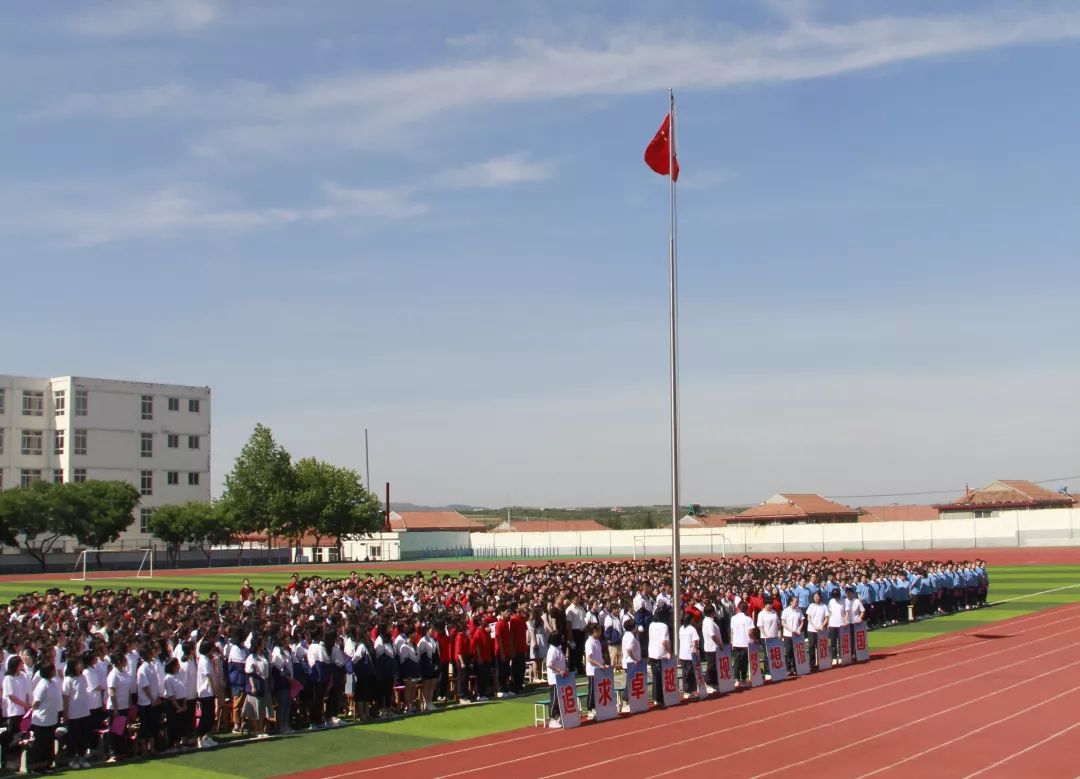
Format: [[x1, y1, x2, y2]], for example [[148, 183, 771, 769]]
[[0, 0, 1080, 506]]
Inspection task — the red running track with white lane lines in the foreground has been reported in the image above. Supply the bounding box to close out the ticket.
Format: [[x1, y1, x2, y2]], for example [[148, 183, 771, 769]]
[[282, 604, 1080, 779]]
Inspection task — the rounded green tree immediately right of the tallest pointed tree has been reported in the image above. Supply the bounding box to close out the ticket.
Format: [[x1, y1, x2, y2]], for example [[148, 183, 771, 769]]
[[295, 457, 382, 552]]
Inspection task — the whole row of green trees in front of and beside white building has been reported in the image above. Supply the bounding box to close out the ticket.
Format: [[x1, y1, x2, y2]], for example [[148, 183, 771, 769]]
[[0, 425, 382, 569]]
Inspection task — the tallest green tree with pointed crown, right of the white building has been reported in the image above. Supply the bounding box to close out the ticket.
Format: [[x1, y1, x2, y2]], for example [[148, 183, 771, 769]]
[[221, 425, 296, 543]]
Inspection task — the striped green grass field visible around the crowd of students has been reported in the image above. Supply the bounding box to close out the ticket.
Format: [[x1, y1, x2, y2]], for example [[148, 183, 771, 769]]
[[8, 565, 1080, 779]]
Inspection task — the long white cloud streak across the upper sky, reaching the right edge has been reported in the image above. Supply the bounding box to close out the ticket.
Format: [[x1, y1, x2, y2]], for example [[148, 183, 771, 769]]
[[35, 3, 1080, 155]]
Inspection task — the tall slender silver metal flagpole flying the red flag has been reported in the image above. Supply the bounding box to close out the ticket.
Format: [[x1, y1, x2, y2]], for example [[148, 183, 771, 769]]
[[667, 89, 683, 661]]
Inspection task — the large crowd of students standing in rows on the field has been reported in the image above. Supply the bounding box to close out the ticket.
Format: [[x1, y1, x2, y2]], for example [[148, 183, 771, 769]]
[[0, 556, 988, 770]]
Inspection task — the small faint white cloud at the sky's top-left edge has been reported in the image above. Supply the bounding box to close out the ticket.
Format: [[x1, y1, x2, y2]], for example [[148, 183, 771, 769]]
[[67, 0, 221, 38]]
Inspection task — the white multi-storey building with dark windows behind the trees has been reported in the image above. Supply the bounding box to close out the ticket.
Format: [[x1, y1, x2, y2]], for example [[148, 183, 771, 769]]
[[0, 375, 211, 550]]
